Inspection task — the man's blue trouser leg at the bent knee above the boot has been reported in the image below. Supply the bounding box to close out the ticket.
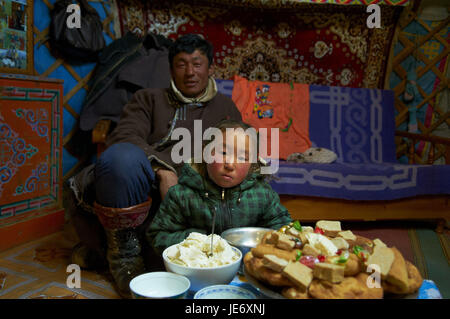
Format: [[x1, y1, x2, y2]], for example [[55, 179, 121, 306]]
[[95, 143, 155, 208]]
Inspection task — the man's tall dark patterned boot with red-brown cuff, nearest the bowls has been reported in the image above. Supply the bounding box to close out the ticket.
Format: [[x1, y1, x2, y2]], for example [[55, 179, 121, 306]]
[[94, 199, 152, 298]]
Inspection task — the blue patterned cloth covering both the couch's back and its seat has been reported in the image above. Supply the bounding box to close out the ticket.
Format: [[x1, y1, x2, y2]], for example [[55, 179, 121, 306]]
[[216, 80, 450, 200]]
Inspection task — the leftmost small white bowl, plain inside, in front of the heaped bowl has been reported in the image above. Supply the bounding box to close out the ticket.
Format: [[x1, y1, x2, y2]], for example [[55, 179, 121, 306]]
[[130, 271, 191, 299]]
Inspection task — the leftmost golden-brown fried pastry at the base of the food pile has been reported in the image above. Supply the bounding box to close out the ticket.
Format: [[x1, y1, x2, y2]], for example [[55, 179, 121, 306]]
[[244, 252, 294, 287]]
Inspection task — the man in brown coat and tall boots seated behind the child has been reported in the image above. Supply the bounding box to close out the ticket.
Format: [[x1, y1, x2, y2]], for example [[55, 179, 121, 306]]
[[72, 34, 241, 297]]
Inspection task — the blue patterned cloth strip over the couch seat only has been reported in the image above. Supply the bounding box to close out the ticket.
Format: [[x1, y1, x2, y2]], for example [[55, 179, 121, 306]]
[[270, 162, 450, 200]]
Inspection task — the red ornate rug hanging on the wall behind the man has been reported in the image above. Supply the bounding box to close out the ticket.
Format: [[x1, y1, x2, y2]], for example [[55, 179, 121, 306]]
[[111, 0, 402, 88]]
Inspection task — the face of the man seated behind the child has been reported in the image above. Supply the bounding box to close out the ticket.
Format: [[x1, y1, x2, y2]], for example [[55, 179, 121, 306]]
[[171, 50, 214, 98]]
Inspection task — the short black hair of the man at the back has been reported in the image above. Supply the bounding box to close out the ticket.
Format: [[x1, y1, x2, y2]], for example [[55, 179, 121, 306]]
[[169, 33, 213, 68]]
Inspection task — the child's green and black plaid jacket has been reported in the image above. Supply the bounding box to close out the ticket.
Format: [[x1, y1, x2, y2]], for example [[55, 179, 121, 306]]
[[146, 164, 292, 253]]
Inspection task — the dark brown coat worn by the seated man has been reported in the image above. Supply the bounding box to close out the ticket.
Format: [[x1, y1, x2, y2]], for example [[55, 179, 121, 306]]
[[106, 89, 242, 173]]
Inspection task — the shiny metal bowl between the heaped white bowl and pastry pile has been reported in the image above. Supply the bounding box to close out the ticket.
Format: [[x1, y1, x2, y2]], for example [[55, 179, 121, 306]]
[[220, 227, 273, 255]]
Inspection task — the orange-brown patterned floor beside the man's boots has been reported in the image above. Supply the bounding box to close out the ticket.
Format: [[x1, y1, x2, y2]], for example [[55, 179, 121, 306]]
[[0, 225, 120, 299]]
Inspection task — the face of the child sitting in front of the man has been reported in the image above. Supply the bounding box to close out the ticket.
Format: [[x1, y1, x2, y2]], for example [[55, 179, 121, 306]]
[[206, 132, 251, 188]]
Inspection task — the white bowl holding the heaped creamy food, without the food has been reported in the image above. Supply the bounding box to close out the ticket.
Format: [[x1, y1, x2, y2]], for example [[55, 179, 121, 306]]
[[162, 245, 242, 291]]
